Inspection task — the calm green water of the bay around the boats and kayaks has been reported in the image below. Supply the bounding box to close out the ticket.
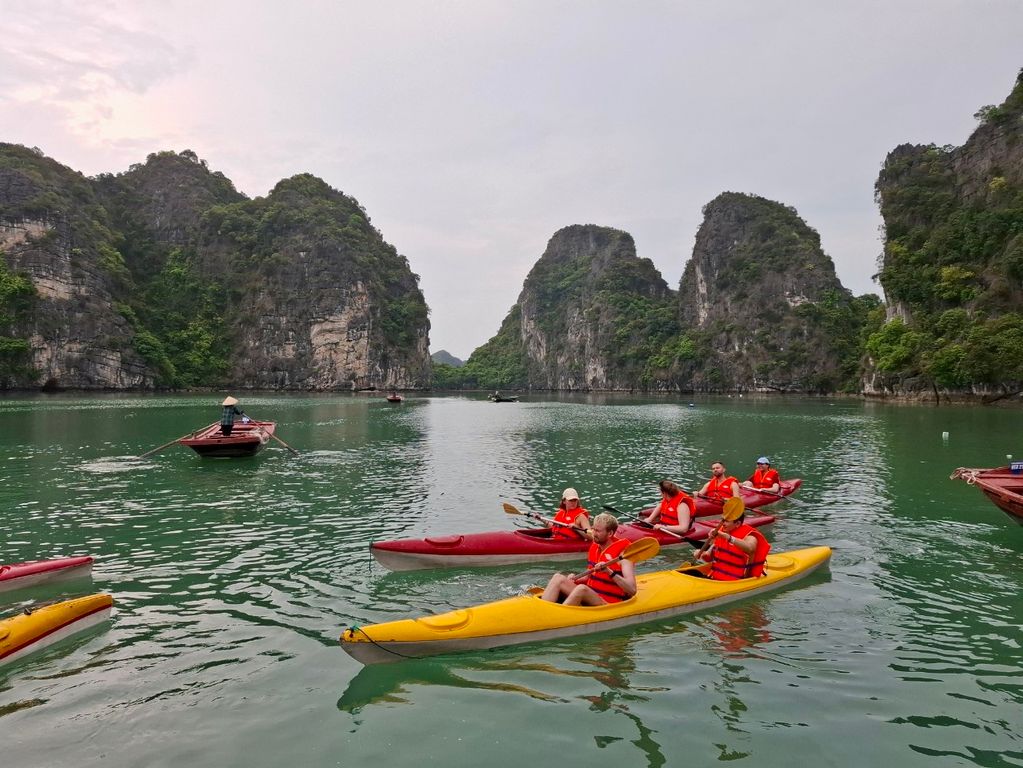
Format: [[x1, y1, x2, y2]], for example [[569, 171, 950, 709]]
[[0, 396, 1023, 768]]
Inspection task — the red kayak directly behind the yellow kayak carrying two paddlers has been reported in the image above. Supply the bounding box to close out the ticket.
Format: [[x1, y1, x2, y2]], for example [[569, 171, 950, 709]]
[[369, 514, 775, 571]]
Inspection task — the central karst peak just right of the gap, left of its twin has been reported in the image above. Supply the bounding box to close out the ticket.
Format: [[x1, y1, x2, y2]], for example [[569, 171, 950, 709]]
[[465, 225, 677, 390]]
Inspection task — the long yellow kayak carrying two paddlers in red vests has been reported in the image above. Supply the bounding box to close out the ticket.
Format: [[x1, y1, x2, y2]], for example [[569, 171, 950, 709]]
[[341, 547, 831, 664]]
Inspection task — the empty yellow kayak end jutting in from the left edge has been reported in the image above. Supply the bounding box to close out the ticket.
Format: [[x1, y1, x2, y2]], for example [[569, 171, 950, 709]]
[[0, 594, 114, 665]]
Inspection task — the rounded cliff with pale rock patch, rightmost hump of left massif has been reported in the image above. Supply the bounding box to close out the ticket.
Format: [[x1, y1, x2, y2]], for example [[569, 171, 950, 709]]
[[197, 175, 431, 390]]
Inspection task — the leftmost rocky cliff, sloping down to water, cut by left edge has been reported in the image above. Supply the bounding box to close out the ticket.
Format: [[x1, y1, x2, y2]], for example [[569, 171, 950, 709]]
[[0, 144, 152, 389]]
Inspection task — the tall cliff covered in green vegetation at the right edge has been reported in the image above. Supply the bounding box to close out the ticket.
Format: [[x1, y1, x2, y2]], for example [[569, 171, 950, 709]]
[[866, 71, 1023, 390]]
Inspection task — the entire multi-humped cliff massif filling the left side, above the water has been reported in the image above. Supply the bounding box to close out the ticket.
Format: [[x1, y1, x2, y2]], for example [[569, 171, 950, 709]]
[[0, 145, 430, 390]]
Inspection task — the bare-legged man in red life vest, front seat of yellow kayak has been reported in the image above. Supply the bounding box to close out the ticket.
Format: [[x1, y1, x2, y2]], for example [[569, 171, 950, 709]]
[[543, 512, 636, 605]]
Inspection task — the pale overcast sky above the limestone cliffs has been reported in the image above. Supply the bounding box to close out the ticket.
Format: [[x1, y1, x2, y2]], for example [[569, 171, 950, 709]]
[[0, 0, 1023, 359]]
